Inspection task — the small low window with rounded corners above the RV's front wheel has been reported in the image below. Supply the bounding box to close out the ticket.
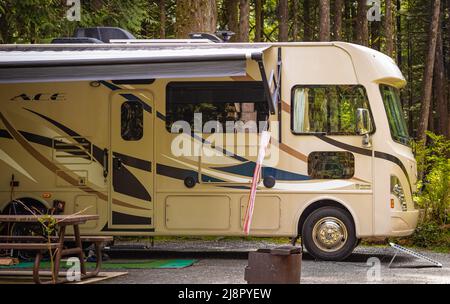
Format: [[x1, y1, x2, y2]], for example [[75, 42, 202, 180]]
[[308, 152, 355, 179]]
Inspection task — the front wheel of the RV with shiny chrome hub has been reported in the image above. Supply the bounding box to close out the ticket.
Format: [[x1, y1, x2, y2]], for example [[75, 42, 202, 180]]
[[302, 207, 357, 261]]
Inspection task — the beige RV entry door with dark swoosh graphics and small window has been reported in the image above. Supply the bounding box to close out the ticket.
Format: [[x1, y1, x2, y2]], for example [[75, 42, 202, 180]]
[[108, 90, 155, 232]]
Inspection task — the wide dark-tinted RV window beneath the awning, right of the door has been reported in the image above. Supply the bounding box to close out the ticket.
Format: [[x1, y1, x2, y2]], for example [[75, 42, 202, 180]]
[[166, 81, 269, 133]]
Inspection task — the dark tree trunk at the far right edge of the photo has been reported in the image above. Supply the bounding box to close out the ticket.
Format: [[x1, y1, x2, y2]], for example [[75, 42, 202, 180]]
[[433, 29, 449, 138]]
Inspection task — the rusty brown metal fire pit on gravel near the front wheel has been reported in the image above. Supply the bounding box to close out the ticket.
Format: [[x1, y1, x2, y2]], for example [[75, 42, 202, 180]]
[[244, 246, 302, 284]]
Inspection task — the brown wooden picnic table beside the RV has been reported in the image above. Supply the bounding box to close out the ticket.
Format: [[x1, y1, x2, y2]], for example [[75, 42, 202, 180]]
[[0, 215, 112, 284]]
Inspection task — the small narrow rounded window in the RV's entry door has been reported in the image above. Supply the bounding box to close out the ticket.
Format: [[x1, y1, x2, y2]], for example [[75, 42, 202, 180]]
[[120, 101, 144, 141]]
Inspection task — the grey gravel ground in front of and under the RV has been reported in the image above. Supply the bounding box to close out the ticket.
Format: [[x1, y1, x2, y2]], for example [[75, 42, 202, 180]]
[[96, 239, 450, 284]]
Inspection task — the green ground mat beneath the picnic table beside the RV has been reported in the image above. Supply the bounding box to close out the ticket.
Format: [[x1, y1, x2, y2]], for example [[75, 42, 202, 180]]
[[0, 260, 197, 269]]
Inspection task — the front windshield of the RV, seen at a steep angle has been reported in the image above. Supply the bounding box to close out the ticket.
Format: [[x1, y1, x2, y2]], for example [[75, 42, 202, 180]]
[[380, 85, 410, 145]]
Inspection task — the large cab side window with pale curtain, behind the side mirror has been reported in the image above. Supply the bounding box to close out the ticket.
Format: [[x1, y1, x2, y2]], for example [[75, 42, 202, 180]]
[[291, 85, 374, 135]]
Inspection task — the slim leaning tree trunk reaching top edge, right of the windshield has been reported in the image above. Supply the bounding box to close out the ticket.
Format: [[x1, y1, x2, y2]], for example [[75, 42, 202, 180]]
[[417, 0, 441, 140]]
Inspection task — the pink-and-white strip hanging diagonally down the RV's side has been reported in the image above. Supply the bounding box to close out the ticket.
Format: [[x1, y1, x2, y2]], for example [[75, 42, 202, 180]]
[[244, 131, 270, 235]]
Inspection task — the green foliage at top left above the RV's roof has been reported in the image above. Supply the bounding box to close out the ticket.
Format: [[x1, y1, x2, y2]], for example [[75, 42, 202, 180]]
[[0, 0, 152, 43]]
